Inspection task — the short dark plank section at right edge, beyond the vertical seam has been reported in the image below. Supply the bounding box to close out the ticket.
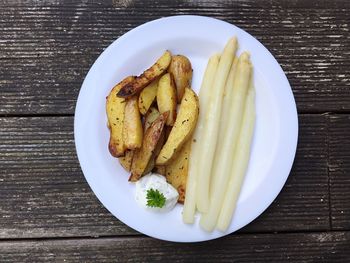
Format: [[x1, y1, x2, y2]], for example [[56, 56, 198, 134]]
[[329, 115, 350, 229]]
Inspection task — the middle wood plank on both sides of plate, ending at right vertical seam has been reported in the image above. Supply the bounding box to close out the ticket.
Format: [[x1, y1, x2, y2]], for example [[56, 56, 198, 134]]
[[0, 115, 329, 238]]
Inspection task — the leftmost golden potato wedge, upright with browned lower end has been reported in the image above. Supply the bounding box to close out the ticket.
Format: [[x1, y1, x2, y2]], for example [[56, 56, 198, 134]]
[[106, 76, 135, 157]]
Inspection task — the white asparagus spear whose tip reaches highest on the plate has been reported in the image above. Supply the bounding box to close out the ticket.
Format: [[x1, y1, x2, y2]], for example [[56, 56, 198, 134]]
[[196, 38, 237, 213]]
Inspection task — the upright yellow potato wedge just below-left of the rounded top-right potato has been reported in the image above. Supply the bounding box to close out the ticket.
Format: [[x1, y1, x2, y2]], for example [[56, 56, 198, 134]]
[[157, 73, 177, 126]]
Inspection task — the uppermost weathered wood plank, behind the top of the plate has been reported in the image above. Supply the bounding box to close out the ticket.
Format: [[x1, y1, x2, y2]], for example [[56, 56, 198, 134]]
[[0, 0, 350, 114]]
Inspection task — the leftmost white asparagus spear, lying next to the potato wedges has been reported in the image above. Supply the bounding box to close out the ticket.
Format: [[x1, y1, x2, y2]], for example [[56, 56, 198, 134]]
[[182, 54, 220, 224]]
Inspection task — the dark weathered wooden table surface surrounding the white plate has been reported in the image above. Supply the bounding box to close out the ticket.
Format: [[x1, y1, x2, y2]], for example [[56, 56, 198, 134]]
[[0, 0, 350, 262]]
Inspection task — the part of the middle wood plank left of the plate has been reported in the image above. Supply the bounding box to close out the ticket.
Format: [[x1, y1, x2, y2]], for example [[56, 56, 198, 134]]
[[0, 117, 135, 238]]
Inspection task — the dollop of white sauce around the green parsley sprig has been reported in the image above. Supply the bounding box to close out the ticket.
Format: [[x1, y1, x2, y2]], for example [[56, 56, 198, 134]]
[[135, 173, 179, 212]]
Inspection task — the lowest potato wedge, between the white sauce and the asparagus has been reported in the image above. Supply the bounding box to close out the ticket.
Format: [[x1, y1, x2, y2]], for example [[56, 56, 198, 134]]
[[166, 139, 192, 204]]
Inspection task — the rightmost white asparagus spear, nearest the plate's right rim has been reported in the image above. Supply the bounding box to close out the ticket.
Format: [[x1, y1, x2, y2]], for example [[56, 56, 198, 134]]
[[216, 87, 255, 232]]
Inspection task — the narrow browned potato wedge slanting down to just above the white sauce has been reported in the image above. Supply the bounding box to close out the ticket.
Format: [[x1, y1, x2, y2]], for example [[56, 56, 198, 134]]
[[129, 112, 169, 182]]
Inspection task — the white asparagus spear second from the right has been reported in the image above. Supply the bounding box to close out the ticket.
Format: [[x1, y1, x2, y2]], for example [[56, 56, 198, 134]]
[[200, 52, 252, 232]]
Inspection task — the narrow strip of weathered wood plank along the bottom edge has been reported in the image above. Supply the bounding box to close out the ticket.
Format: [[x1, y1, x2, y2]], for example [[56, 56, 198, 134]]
[[0, 232, 350, 262]]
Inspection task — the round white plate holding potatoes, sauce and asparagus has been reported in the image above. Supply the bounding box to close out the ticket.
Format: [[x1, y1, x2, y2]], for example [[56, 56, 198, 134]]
[[74, 16, 298, 242]]
